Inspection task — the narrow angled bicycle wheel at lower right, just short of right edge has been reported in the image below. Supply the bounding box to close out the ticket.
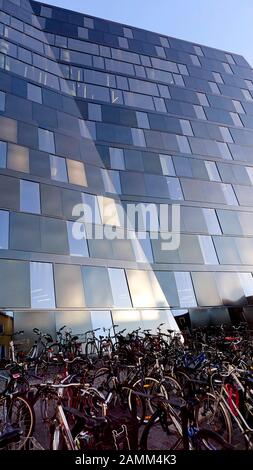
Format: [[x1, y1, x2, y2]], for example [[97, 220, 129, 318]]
[[195, 393, 232, 450]]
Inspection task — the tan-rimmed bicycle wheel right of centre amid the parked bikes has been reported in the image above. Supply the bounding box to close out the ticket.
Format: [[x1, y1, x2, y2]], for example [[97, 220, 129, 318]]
[[128, 377, 168, 423]]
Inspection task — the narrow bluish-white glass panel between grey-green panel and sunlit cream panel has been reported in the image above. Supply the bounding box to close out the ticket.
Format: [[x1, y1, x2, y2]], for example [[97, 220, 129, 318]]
[[108, 268, 132, 308]]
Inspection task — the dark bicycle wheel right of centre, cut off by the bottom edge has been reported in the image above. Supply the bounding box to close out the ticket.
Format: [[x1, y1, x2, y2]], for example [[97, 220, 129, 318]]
[[140, 404, 183, 451]]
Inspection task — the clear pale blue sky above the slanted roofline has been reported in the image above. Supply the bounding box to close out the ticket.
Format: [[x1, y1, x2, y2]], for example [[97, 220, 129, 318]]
[[35, 0, 253, 66]]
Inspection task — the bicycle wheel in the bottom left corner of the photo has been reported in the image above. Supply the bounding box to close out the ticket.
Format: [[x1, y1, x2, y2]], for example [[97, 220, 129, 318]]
[[0, 397, 35, 450]]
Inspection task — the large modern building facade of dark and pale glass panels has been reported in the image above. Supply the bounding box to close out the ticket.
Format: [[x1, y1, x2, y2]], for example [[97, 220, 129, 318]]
[[0, 0, 253, 346]]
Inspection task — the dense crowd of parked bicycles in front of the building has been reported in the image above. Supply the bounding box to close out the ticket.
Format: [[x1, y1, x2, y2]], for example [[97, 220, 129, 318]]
[[0, 324, 253, 450]]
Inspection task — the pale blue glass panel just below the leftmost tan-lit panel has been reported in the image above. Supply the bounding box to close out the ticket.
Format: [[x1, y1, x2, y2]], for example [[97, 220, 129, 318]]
[[20, 180, 40, 214]]
